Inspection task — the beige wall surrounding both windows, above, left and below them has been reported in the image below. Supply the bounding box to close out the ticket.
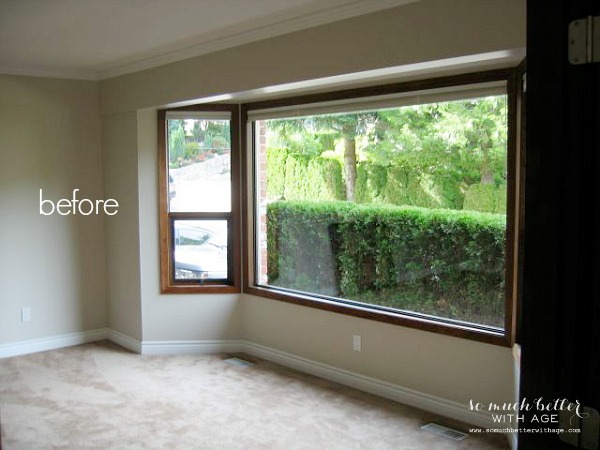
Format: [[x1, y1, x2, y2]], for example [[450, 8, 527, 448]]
[[95, 0, 525, 403]]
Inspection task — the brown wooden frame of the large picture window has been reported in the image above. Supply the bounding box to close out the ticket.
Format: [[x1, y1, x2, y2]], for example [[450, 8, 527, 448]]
[[241, 68, 522, 347]]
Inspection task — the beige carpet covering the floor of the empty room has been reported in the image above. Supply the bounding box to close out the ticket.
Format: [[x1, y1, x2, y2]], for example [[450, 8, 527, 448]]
[[0, 342, 508, 450]]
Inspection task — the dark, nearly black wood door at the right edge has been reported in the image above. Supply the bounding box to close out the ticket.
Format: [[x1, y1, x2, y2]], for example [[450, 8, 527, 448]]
[[517, 0, 600, 450]]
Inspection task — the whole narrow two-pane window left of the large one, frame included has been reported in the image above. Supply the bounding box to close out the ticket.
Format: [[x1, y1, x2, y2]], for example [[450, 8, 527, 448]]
[[159, 106, 239, 292]]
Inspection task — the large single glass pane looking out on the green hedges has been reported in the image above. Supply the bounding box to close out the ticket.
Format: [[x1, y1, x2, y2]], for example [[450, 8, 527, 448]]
[[255, 95, 507, 328]]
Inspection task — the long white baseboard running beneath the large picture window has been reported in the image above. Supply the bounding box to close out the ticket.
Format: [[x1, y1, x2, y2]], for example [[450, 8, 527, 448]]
[[241, 341, 497, 428]]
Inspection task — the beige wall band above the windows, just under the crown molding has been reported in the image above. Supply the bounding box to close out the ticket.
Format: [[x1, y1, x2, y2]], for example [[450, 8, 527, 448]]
[[101, 0, 525, 114]]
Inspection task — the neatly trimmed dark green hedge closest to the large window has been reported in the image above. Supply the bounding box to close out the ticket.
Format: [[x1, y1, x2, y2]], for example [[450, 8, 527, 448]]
[[267, 201, 506, 327]]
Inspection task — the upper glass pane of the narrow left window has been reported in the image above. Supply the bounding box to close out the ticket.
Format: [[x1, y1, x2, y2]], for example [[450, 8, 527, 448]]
[[167, 118, 231, 212]]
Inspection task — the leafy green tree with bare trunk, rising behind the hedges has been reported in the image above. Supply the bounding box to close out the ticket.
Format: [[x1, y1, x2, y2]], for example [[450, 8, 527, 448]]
[[268, 96, 507, 203]]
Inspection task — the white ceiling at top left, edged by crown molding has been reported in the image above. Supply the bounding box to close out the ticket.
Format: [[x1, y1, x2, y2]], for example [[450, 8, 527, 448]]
[[0, 0, 419, 80]]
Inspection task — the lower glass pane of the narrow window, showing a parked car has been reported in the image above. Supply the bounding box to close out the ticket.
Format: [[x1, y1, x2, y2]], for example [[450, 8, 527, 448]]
[[173, 219, 228, 281]]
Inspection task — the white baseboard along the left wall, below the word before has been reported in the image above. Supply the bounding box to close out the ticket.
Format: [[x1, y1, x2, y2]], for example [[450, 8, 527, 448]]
[[0, 328, 110, 358]]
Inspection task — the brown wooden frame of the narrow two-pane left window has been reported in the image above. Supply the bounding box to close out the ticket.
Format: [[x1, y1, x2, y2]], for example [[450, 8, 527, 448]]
[[157, 105, 241, 294]]
